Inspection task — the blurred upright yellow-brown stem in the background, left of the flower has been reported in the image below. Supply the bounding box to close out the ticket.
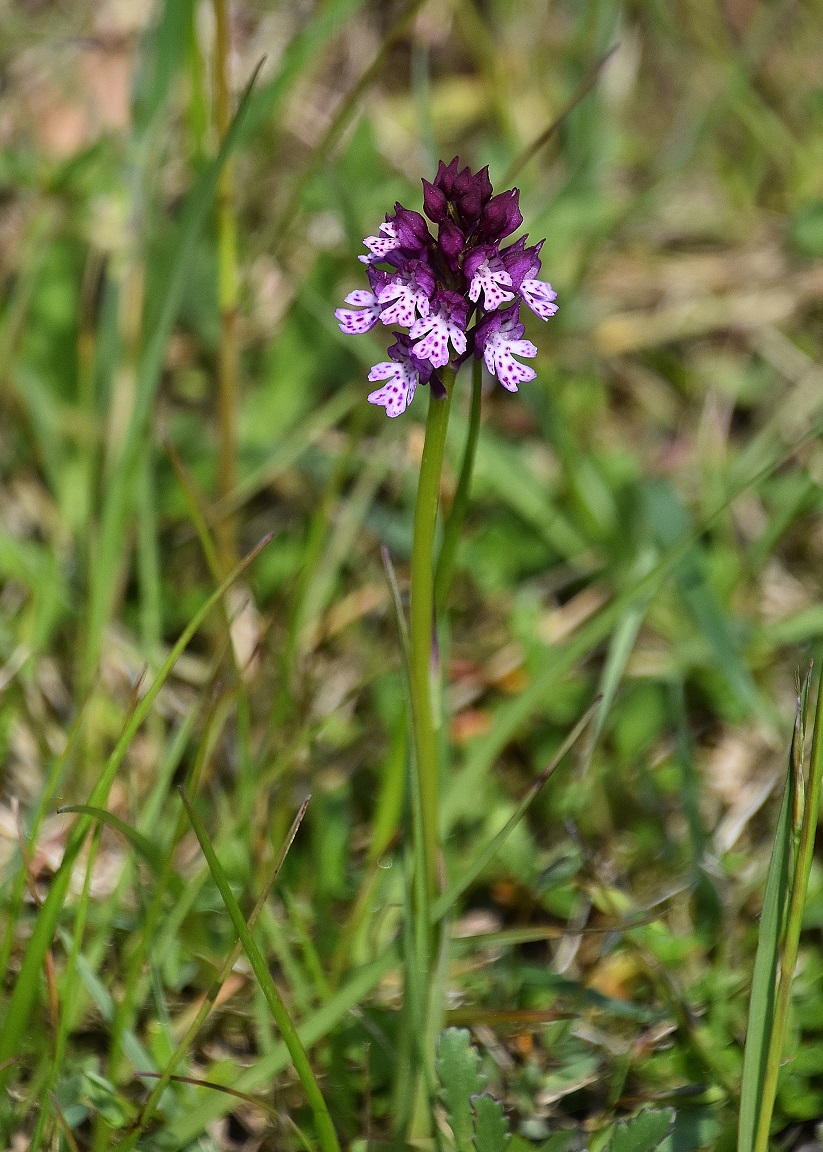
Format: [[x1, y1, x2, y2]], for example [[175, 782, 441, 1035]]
[[213, 0, 237, 576]]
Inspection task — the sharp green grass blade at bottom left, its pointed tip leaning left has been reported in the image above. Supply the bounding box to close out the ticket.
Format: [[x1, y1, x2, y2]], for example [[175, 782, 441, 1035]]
[[180, 789, 340, 1152]]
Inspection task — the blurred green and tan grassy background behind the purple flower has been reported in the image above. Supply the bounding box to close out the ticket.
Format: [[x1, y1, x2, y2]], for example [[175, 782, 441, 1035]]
[[0, 0, 823, 1152]]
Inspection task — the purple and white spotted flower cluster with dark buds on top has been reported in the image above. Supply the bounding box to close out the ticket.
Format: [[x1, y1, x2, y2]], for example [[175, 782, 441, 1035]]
[[334, 157, 557, 416]]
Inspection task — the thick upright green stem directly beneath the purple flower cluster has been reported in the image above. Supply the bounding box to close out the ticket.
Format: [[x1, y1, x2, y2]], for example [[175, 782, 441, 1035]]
[[409, 369, 454, 900]]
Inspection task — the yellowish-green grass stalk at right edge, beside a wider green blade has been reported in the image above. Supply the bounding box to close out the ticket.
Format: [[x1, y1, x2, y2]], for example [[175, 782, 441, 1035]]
[[753, 664, 823, 1152]]
